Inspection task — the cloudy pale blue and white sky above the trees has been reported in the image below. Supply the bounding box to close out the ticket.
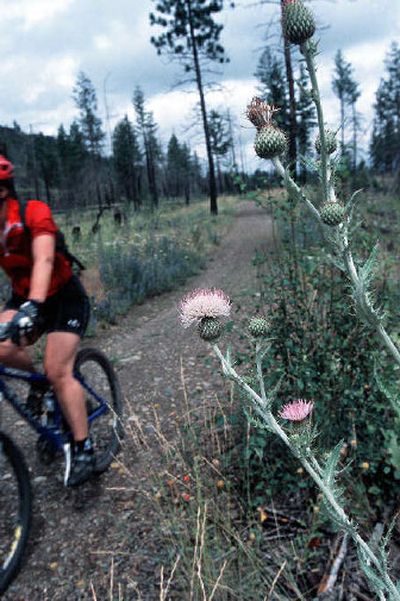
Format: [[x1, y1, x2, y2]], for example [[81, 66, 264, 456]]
[[0, 0, 400, 167]]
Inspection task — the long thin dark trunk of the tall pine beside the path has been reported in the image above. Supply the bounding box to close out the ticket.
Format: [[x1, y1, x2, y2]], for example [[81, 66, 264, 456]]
[[185, 0, 218, 215]]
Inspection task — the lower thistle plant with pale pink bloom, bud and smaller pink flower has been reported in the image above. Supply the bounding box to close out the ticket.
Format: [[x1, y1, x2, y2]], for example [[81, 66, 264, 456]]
[[180, 289, 400, 601]]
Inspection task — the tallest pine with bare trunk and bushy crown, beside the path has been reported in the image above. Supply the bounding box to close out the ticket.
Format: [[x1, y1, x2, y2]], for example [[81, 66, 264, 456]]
[[150, 0, 227, 215]]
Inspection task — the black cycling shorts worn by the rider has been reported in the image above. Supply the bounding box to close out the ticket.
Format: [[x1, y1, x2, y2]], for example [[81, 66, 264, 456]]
[[4, 275, 90, 337]]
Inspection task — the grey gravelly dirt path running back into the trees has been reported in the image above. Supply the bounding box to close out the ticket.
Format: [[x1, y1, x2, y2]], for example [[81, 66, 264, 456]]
[[3, 203, 271, 601]]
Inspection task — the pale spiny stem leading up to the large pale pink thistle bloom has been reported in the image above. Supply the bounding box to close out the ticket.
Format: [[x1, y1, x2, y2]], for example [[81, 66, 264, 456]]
[[212, 344, 400, 601]]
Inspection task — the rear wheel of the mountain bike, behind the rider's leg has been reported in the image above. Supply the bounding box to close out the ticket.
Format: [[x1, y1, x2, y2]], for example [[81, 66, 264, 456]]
[[74, 348, 124, 474]]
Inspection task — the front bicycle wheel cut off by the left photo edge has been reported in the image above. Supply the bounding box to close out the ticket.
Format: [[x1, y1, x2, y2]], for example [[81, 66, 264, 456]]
[[0, 432, 32, 595]]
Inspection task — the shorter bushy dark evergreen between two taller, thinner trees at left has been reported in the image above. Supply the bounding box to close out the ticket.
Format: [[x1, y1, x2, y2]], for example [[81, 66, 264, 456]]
[[112, 115, 142, 210]]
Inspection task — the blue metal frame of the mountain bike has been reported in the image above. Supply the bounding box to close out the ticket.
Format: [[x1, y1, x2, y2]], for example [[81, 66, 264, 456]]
[[0, 364, 109, 453]]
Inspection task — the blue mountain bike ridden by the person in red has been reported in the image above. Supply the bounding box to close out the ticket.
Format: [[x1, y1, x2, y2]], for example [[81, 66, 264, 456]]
[[0, 323, 123, 595]]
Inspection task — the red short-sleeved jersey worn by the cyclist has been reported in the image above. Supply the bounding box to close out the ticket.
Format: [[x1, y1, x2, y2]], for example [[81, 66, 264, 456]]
[[0, 198, 72, 298]]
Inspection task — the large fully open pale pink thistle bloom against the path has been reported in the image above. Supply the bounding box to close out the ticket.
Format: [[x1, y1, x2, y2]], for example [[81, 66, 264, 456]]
[[179, 288, 231, 328]]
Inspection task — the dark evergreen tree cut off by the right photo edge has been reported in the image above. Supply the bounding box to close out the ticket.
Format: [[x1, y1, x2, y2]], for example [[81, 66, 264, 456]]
[[370, 43, 400, 175]]
